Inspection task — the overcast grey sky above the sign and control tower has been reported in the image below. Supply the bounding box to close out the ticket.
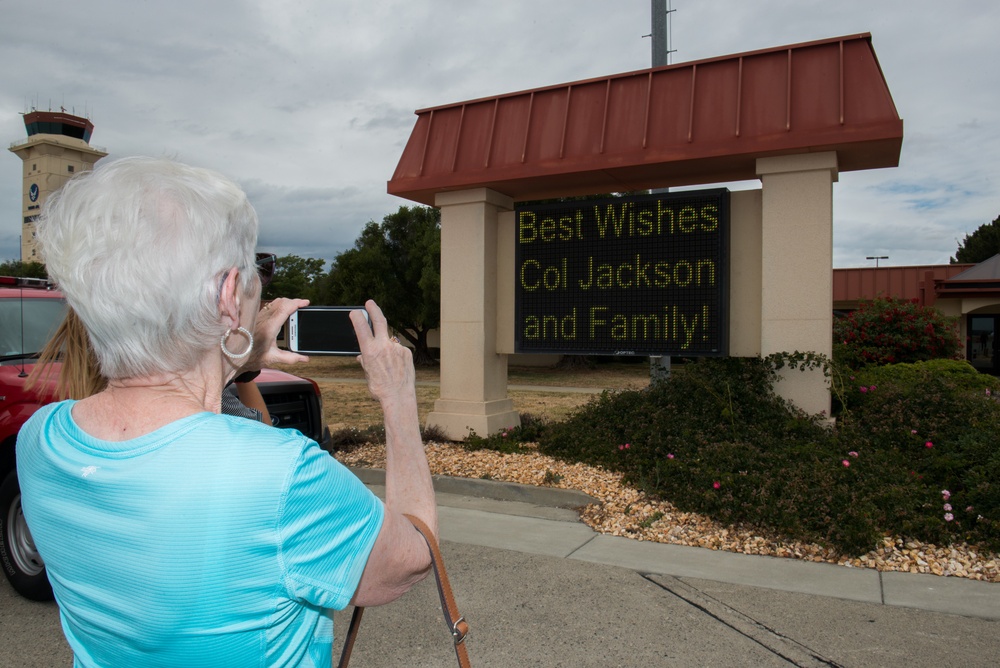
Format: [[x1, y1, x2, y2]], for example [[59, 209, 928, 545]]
[[0, 0, 1000, 267]]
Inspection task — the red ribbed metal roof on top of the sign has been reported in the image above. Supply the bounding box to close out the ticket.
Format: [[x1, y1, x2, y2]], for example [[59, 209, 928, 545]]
[[388, 33, 903, 204]]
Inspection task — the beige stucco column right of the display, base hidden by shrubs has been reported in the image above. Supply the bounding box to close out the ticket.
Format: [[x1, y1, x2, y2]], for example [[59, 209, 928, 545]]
[[757, 152, 837, 415]]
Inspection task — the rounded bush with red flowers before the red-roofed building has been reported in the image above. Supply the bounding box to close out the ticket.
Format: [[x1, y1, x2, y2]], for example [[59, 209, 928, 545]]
[[833, 297, 962, 368]]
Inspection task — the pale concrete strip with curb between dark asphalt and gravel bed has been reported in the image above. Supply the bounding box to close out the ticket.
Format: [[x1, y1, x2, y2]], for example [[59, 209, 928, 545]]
[[354, 469, 1000, 620]]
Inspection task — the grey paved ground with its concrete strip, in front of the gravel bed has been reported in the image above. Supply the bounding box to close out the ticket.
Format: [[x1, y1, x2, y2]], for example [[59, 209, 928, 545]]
[[0, 470, 1000, 668]]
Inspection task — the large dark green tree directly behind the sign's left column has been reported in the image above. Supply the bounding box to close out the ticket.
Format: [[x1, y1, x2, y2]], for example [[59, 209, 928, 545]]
[[320, 206, 441, 365]]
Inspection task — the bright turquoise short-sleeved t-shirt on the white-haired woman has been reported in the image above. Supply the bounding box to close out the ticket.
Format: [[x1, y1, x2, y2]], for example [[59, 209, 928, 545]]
[[17, 401, 384, 668]]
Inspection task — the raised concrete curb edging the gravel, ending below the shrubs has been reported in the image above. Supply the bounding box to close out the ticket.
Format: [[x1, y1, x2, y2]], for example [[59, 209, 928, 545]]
[[348, 467, 598, 510]]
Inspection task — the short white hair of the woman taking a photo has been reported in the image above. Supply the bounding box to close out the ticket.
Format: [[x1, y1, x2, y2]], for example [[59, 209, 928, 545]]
[[37, 157, 258, 379]]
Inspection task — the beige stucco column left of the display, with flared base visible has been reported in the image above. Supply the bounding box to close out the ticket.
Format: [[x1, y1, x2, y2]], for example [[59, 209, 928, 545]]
[[427, 188, 520, 440]]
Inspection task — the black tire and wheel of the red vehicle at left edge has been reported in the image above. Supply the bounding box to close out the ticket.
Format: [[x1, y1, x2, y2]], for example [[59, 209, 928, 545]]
[[0, 471, 52, 601]]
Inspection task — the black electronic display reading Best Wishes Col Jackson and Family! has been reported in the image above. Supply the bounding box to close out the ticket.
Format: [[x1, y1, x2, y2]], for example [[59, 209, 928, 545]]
[[514, 189, 729, 357]]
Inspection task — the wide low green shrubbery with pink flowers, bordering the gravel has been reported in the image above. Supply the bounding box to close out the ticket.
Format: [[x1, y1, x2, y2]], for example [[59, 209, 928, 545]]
[[539, 356, 1000, 554]]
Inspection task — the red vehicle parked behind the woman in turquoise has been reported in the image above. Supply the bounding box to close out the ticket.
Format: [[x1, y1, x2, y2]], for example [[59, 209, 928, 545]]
[[0, 276, 330, 601]]
